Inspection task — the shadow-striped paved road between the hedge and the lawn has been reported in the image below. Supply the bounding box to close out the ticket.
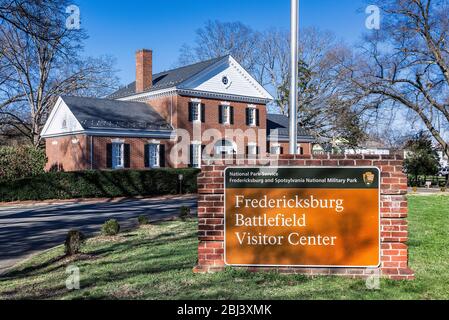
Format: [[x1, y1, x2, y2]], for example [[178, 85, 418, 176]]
[[0, 196, 197, 274]]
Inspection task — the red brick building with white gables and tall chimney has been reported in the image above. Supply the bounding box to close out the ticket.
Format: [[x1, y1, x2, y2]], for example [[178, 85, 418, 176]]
[[42, 50, 313, 171]]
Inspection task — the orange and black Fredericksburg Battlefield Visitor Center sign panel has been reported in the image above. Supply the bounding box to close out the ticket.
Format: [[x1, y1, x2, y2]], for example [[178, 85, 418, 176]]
[[224, 167, 380, 268]]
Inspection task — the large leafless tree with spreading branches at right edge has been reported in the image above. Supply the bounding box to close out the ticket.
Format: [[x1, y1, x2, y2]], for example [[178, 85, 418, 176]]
[[342, 0, 449, 155]]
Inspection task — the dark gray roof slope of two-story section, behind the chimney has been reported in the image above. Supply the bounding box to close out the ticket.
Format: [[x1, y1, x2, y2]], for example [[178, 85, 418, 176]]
[[108, 56, 227, 99]]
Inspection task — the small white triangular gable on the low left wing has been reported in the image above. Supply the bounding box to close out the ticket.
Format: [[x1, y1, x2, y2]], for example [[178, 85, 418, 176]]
[[42, 98, 84, 138]]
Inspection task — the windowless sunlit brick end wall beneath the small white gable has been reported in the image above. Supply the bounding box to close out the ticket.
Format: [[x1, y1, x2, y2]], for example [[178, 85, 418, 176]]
[[45, 135, 89, 171]]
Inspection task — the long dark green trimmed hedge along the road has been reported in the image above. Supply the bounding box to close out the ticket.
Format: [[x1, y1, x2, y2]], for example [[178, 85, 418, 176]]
[[0, 169, 199, 202]]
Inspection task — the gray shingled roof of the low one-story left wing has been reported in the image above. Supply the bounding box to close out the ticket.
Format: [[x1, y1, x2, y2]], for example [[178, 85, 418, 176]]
[[61, 96, 173, 130]]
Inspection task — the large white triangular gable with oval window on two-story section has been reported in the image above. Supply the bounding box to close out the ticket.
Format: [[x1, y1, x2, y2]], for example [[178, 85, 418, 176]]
[[178, 56, 273, 100]]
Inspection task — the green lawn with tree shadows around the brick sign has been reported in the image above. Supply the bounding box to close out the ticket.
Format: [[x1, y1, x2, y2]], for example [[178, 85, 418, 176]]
[[0, 196, 449, 299]]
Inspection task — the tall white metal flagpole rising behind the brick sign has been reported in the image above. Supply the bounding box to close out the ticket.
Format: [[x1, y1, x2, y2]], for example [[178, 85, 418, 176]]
[[289, 0, 299, 154]]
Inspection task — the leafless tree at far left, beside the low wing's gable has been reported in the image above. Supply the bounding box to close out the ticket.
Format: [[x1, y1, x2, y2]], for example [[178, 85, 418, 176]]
[[0, 0, 117, 147]]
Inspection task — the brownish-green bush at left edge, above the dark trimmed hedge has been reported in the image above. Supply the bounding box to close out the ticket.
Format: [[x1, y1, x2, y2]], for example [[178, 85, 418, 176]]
[[0, 146, 47, 181]]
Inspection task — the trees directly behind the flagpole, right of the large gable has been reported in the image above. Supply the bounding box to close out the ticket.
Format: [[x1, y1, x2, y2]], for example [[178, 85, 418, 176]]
[[277, 28, 365, 147]]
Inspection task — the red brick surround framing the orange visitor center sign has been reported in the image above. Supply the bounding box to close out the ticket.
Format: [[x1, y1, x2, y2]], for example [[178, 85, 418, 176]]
[[194, 155, 414, 280]]
